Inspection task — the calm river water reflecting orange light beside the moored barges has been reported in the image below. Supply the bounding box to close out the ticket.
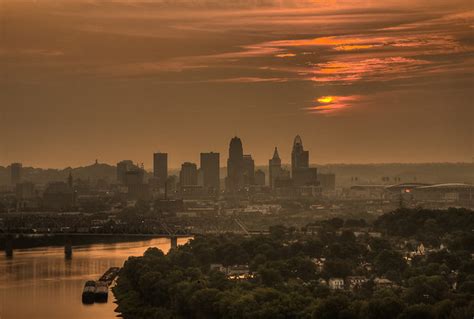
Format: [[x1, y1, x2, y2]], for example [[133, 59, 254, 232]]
[[0, 238, 188, 319]]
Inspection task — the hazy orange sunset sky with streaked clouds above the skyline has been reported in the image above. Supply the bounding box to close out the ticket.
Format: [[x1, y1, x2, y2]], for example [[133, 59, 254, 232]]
[[0, 0, 474, 168]]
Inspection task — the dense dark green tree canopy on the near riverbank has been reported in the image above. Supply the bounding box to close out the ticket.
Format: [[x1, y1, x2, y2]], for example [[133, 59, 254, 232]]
[[114, 210, 474, 319]]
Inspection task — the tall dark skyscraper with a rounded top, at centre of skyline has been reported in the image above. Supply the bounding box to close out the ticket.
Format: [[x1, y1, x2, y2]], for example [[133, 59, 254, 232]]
[[226, 136, 244, 192]]
